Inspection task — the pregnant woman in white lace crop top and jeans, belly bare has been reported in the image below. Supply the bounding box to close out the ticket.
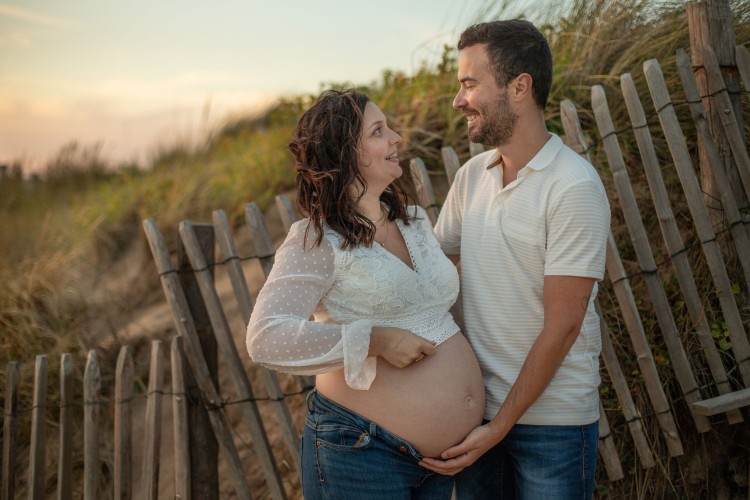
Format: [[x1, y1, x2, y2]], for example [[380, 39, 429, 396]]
[[247, 89, 484, 500]]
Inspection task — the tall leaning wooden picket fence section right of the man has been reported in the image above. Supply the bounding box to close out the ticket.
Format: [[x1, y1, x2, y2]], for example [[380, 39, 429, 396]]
[[562, 46, 750, 477]]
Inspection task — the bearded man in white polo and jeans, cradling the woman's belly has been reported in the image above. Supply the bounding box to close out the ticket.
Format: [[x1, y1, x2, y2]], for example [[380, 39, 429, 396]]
[[422, 20, 610, 499]]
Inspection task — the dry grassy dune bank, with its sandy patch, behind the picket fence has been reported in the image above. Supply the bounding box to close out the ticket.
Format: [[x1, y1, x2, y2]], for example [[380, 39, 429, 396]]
[[0, 0, 750, 499]]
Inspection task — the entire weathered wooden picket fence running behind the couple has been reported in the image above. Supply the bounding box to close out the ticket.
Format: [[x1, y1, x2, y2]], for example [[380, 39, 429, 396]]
[[0, 46, 750, 499]]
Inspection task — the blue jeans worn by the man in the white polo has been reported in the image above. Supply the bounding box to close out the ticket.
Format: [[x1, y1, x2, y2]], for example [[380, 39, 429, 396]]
[[456, 422, 599, 500]]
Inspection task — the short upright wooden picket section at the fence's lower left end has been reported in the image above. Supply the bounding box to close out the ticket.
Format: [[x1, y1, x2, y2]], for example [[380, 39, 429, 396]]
[[2, 337, 188, 500]]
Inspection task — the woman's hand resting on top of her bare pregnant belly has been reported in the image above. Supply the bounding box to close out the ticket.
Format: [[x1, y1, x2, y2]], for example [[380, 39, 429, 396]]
[[369, 326, 437, 368]]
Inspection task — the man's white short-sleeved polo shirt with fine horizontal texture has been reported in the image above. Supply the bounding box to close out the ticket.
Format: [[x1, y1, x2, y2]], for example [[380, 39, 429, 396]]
[[435, 134, 610, 425]]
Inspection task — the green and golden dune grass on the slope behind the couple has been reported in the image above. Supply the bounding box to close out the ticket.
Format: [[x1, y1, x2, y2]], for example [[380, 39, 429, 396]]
[[0, 0, 750, 498]]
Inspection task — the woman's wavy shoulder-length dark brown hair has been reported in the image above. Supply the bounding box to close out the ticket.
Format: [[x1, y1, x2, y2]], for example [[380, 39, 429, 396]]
[[289, 89, 418, 248]]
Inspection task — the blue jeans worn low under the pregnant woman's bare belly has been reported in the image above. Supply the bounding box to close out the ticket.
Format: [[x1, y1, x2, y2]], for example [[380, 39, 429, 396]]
[[302, 390, 453, 500]]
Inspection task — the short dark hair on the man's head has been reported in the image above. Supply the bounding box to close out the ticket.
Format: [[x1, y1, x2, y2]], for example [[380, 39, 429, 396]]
[[458, 19, 552, 109]]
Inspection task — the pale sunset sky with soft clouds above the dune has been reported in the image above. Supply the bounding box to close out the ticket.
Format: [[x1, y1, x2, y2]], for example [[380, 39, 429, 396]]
[[0, 0, 512, 171]]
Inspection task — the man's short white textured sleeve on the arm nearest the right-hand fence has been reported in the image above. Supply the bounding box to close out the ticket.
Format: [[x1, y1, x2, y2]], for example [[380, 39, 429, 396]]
[[544, 179, 610, 280]]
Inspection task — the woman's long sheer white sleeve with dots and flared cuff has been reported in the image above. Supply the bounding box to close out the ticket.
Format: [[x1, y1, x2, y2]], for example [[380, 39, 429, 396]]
[[246, 221, 376, 389]]
